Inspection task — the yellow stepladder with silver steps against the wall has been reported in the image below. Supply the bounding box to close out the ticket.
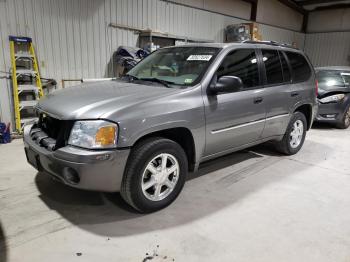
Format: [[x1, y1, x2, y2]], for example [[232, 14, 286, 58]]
[[9, 36, 44, 134]]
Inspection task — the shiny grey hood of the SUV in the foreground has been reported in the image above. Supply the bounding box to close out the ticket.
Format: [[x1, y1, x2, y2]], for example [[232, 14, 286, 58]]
[[37, 81, 181, 120]]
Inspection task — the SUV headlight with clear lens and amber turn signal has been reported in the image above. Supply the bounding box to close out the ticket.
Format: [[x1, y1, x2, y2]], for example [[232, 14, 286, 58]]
[[68, 120, 118, 149]]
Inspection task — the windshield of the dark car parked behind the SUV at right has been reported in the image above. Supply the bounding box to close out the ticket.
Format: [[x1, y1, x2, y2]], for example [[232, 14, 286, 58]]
[[317, 70, 349, 90]]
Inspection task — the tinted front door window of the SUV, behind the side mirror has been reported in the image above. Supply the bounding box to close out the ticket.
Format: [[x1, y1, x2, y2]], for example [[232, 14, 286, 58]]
[[217, 49, 259, 88]]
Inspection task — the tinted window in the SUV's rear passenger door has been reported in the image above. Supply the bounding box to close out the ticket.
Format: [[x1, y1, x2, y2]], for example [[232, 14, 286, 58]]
[[261, 49, 283, 85]]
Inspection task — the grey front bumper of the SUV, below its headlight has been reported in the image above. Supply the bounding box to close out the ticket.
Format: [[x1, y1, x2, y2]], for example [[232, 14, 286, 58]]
[[23, 125, 130, 192]]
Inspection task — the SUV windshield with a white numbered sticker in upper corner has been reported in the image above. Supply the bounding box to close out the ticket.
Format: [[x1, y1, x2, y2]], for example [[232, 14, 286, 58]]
[[127, 47, 220, 87]]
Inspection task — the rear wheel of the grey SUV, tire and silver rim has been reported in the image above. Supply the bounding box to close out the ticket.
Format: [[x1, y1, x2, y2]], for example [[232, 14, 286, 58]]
[[275, 112, 307, 155]]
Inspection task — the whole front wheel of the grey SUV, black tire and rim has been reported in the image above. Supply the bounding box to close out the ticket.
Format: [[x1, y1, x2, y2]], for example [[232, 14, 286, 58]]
[[120, 137, 188, 213]]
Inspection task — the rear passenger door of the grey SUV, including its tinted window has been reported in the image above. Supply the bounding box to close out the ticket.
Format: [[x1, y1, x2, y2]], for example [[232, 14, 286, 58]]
[[261, 49, 294, 138]]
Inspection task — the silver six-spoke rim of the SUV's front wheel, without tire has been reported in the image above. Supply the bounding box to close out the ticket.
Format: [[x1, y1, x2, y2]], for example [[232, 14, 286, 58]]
[[141, 153, 180, 201]]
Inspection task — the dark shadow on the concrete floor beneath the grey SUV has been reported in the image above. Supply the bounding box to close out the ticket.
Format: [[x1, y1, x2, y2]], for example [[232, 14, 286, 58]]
[[35, 143, 314, 236]]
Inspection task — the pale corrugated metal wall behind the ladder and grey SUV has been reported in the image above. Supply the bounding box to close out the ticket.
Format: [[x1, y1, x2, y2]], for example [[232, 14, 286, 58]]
[[0, 0, 304, 127]]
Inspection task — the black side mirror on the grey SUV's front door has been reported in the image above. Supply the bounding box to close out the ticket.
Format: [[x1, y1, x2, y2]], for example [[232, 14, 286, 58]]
[[209, 76, 243, 94]]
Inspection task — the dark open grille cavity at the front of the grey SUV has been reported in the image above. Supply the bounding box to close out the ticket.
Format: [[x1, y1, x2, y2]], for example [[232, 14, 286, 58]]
[[30, 114, 74, 151]]
